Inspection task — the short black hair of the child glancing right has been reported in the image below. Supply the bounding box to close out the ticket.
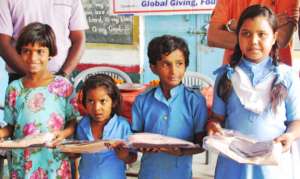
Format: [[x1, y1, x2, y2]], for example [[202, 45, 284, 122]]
[[148, 35, 190, 67]]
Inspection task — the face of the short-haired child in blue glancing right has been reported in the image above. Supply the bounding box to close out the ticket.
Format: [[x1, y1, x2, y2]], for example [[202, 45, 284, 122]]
[[151, 49, 186, 90]]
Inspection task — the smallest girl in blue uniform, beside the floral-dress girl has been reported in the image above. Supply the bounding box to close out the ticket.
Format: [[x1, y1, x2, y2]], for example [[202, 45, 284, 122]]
[[75, 74, 137, 179]]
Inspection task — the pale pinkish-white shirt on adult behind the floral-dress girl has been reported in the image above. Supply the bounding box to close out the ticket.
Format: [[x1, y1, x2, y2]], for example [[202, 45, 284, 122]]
[[0, 0, 88, 72]]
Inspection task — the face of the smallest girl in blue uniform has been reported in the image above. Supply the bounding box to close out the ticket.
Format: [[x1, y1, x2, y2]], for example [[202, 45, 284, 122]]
[[85, 87, 113, 123]]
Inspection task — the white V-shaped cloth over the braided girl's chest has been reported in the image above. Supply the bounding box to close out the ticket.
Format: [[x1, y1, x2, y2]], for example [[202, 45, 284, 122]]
[[231, 67, 275, 114]]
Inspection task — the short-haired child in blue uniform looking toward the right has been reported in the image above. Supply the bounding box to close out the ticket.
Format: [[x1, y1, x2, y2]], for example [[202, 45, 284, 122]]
[[132, 35, 207, 179]]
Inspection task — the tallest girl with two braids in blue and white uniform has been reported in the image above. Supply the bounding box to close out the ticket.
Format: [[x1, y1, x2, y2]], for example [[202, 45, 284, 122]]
[[207, 5, 300, 179]]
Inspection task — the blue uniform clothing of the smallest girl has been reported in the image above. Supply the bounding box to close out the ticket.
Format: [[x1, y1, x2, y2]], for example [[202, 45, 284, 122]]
[[75, 115, 131, 179]]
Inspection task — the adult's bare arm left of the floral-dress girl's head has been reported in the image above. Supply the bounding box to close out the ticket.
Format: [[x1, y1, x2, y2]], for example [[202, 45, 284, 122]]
[[0, 34, 26, 74]]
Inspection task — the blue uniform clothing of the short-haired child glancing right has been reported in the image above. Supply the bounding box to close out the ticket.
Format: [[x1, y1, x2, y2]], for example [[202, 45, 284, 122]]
[[132, 84, 207, 179]]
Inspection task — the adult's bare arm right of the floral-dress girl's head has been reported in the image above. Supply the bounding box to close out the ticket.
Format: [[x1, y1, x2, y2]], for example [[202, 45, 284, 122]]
[[60, 30, 85, 75]]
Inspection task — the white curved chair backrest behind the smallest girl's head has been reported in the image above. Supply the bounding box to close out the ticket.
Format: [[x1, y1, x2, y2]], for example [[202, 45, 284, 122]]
[[74, 67, 132, 90]]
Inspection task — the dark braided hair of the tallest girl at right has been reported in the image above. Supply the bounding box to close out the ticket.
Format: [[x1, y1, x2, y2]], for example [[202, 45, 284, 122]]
[[217, 4, 279, 107]]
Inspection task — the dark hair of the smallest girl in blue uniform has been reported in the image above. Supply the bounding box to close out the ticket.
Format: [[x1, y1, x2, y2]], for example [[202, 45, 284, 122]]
[[82, 74, 122, 117]]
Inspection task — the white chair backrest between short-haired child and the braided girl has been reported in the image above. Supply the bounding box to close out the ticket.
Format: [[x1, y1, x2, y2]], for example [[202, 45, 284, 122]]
[[182, 71, 214, 89]]
